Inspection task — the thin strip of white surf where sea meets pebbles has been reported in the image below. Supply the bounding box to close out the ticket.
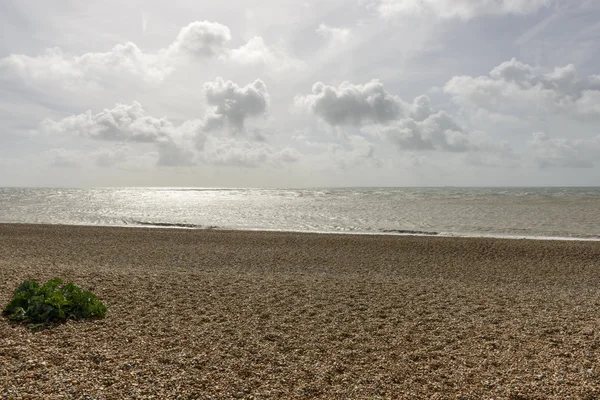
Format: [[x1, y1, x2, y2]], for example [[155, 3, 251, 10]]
[[0, 222, 600, 242]]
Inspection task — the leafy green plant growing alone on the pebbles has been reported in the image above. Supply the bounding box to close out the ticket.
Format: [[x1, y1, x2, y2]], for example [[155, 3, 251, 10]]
[[2, 278, 108, 328]]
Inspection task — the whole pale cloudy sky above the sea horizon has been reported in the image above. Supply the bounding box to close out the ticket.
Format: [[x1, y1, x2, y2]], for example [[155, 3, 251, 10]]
[[0, 0, 600, 187]]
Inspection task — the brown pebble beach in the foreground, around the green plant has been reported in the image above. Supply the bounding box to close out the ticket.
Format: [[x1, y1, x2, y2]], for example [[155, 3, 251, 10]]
[[0, 224, 600, 399]]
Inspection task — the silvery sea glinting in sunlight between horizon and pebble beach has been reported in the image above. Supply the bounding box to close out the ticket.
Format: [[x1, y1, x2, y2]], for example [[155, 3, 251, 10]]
[[0, 188, 600, 240]]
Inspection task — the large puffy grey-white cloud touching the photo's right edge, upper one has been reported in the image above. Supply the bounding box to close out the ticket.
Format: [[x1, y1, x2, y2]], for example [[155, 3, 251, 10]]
[[444, 58, 600, 119]]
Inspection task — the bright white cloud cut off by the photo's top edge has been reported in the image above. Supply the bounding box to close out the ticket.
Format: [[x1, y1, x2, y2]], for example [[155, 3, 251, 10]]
[[376, 0, 555, 20]]
